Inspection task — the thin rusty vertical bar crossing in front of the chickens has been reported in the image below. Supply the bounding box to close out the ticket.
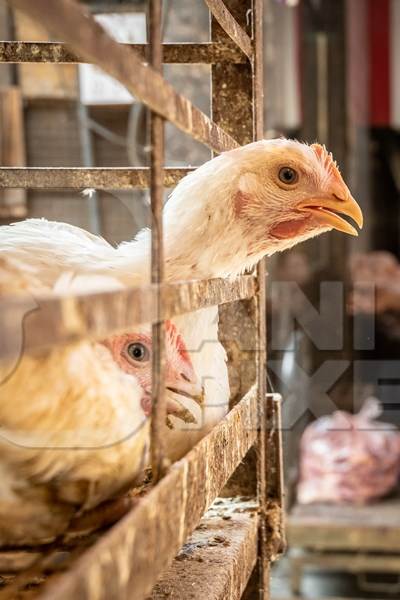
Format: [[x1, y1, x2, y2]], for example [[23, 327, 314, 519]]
[[149, 0, 166, 482]]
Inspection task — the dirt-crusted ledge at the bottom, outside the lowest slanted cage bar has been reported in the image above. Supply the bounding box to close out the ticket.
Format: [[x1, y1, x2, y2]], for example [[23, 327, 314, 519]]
[[151, 498, 258, 600]]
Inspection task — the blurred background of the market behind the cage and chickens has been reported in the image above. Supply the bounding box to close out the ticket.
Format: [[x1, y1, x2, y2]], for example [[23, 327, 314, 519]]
[[0, 0, 400, 598]]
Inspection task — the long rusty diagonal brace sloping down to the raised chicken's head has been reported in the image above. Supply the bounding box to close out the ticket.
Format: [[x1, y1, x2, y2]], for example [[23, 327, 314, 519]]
[[8, 0, 238, 152]]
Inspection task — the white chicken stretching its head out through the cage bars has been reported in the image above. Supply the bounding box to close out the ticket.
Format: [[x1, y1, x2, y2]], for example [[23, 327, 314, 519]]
[[0, 139, 362, 458]]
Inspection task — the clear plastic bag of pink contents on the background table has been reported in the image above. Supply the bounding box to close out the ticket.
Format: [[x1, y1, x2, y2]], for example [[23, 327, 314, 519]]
[[297, 398, 400, 504]]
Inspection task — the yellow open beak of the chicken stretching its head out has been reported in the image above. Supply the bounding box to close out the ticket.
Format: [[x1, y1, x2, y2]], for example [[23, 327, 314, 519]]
[[297, 192, 364, 236]]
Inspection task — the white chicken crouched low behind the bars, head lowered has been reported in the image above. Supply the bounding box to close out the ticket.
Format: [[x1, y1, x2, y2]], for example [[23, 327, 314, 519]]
[[0, 257, 200, 545]]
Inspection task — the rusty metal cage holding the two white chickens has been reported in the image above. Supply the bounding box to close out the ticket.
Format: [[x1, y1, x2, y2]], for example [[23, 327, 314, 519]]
[[0, 0, 284, 600]]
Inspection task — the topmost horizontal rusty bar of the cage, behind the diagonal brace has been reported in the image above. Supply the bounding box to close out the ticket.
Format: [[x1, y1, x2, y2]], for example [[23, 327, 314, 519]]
[[0, 41, 247, 64]]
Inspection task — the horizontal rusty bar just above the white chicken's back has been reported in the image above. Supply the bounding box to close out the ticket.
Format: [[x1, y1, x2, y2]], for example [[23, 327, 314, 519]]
[[0, 167, 195, 190]]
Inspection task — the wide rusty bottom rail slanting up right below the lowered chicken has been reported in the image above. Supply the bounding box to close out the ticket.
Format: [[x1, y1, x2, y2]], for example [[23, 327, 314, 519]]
[[41, 390, 257, 600]]
